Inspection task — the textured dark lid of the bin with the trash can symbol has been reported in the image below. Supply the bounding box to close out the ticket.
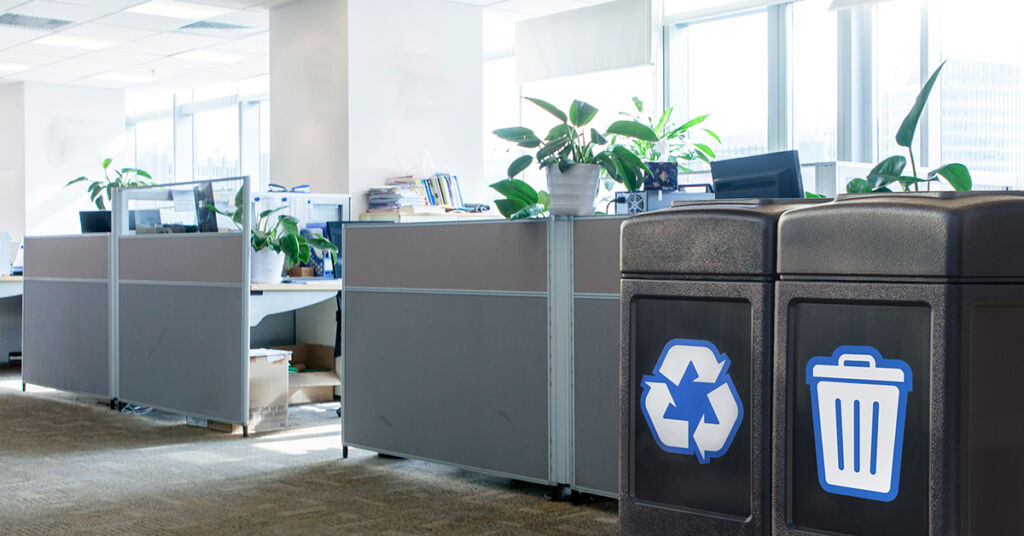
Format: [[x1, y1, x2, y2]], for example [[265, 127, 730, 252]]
[[778, 192, 1024, 281]]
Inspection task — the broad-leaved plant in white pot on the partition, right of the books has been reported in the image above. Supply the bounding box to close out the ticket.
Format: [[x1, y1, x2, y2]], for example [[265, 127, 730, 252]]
[[490, 97, 657, 219]]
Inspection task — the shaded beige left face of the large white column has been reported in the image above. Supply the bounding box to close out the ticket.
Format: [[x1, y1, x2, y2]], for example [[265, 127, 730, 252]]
[[270, 0, 349, 194]]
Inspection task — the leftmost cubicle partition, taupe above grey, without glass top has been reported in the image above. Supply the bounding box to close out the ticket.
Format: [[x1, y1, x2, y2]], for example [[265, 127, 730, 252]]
[[22, 233, 117, 400]]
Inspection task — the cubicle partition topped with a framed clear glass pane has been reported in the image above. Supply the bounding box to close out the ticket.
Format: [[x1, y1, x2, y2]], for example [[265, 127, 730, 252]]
[[114, 179, 250, 425]]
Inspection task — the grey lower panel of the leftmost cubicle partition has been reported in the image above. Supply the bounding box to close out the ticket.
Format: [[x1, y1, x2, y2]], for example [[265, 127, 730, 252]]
[[22, 279, 111, 398]]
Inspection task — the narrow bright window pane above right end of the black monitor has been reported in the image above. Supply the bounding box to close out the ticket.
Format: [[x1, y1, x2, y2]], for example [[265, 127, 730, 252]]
[[791, 0, 839, 163]]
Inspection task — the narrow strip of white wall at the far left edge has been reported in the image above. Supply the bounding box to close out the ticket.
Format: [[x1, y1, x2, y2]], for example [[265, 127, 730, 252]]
[[0, 83, 25, 242]]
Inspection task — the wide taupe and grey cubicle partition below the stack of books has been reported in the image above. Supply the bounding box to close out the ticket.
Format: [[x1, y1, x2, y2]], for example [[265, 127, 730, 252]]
[[342, 221, 558, 484]]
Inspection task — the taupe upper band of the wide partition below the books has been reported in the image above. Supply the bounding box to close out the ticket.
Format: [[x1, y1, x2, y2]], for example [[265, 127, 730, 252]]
[[344, 221, 548, 292]]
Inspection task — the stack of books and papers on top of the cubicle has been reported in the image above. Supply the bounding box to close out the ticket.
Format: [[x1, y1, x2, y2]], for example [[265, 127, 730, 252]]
[[367, 173, 463, 214]]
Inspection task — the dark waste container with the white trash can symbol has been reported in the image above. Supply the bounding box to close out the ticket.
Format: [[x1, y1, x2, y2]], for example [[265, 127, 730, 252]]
[[772, 194, 1024, 536]]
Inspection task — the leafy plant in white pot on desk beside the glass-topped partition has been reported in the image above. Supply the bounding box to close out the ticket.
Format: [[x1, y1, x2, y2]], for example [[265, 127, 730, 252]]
[[206, 190, 338, 283]]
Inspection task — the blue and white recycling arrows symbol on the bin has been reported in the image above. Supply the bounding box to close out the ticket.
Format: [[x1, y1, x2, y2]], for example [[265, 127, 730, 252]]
[[640, 339, 743, 463]]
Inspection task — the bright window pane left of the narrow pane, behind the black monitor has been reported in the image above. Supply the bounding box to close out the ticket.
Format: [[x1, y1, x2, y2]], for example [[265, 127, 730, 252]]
[[667, 10, 768, 158]]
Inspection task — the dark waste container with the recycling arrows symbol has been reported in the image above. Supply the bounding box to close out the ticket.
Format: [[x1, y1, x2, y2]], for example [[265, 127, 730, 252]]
[[618, 200, 823, 535]]
